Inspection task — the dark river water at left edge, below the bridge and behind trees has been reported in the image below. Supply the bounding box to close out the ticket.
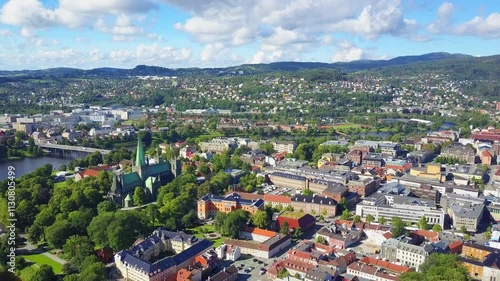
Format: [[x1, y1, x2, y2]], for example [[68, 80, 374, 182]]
[[0, 156, 71, 180]]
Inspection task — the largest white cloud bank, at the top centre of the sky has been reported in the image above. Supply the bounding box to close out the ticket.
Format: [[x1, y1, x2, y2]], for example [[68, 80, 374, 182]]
[[170, 0, 417, 45]]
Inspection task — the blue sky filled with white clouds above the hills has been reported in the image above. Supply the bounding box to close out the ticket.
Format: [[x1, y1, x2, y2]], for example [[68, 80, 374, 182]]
[[0, 0, 500, 70]]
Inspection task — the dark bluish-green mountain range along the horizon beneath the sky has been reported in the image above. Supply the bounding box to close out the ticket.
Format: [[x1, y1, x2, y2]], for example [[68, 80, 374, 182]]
[[0, 53, 492, 79]]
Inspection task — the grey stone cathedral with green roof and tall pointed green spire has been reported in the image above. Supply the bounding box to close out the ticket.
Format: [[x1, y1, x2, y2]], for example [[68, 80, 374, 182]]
[[109, 138, 178, 207]]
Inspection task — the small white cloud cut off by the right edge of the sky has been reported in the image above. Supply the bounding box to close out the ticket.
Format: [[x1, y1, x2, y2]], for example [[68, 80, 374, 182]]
[[453, 13, 500, 38]]
